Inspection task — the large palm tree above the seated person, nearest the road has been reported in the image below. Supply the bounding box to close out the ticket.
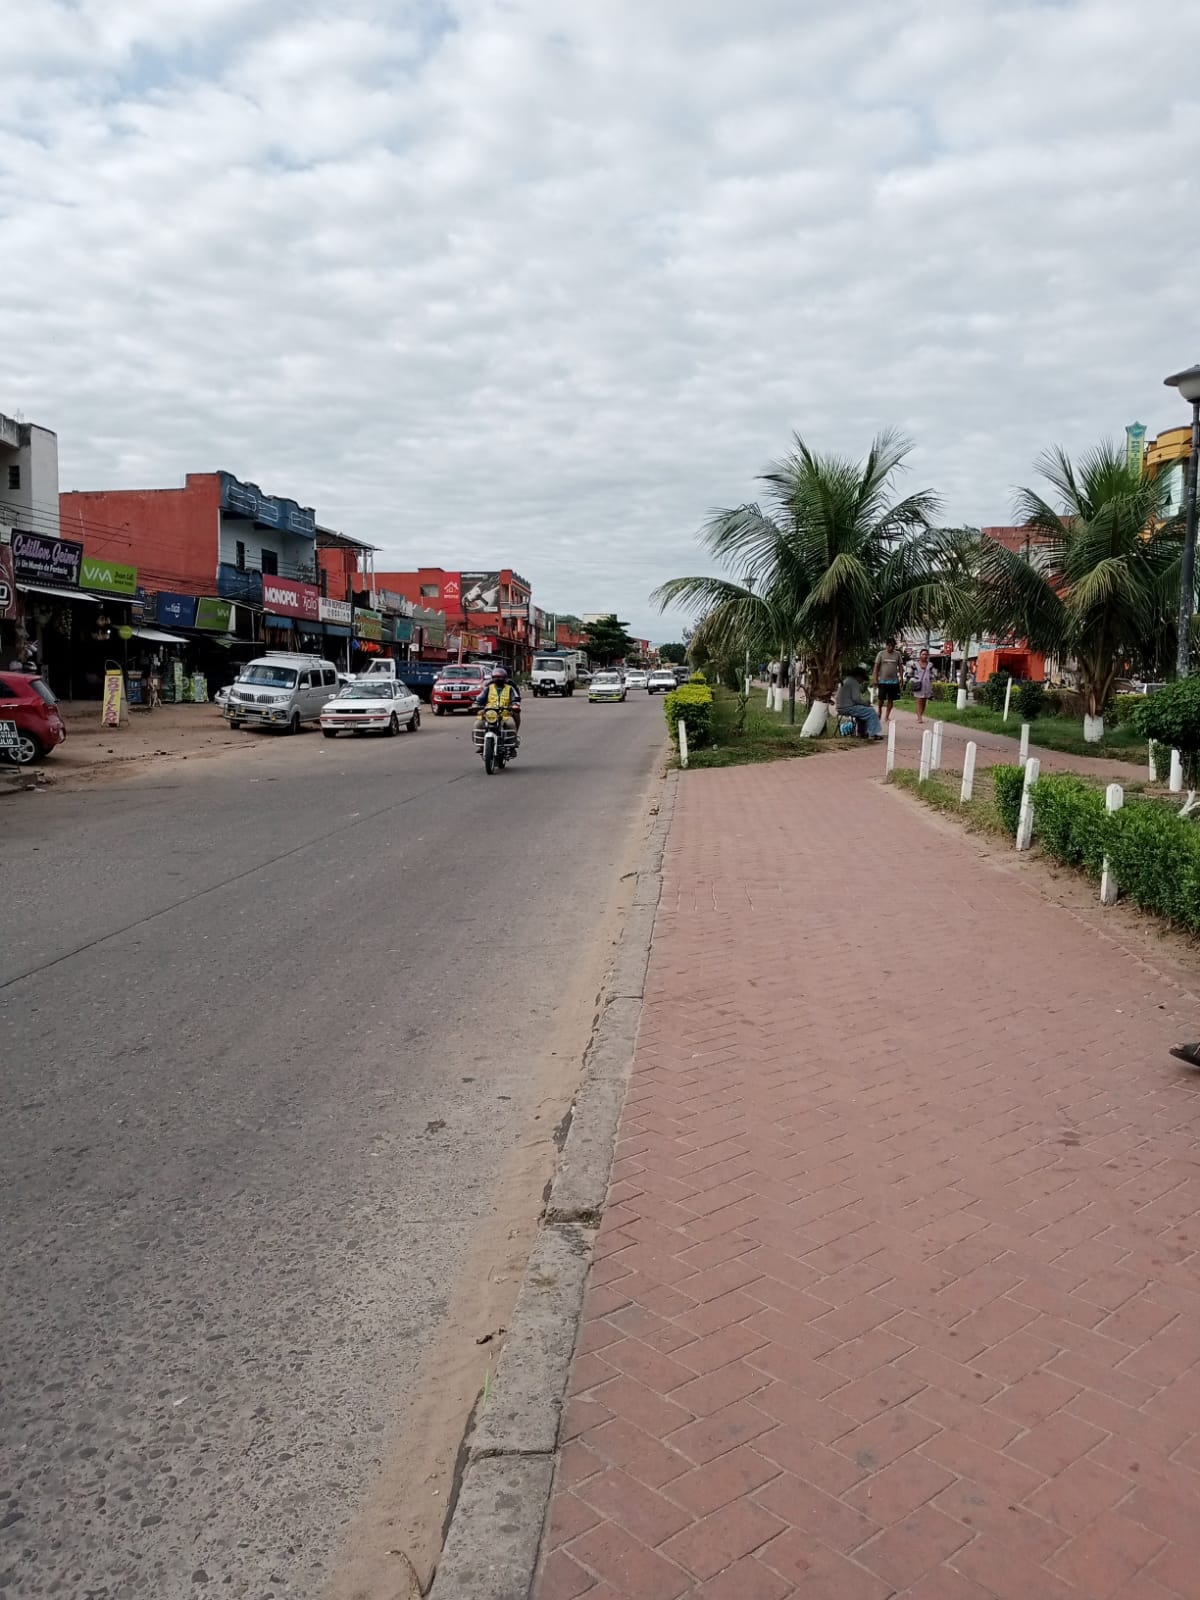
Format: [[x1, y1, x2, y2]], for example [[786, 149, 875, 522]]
[[653, 430, 936, 736]]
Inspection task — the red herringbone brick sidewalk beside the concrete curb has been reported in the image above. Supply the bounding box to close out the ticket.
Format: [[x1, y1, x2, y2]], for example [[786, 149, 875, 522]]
[[536, 752, 1200, 1600]]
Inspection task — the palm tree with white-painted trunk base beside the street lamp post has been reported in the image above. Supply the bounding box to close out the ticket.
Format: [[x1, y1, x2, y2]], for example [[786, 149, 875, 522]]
[[981, 443, 1182, 744]]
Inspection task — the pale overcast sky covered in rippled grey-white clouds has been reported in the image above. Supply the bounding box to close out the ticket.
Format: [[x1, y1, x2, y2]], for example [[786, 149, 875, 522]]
[[0, 0, 1200, 638]]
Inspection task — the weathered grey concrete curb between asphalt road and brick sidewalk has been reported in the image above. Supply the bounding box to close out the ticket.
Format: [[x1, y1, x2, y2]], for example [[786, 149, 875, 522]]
[[430, 773, 678, 1600]]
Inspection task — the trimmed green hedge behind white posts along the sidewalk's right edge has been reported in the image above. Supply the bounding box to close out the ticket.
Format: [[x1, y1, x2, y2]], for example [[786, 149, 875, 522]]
[[1017, 766, 1200, 933]]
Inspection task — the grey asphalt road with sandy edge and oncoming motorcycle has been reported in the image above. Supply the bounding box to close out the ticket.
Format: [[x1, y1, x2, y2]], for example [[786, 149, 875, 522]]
[[0, 694, 664, 1600]]
